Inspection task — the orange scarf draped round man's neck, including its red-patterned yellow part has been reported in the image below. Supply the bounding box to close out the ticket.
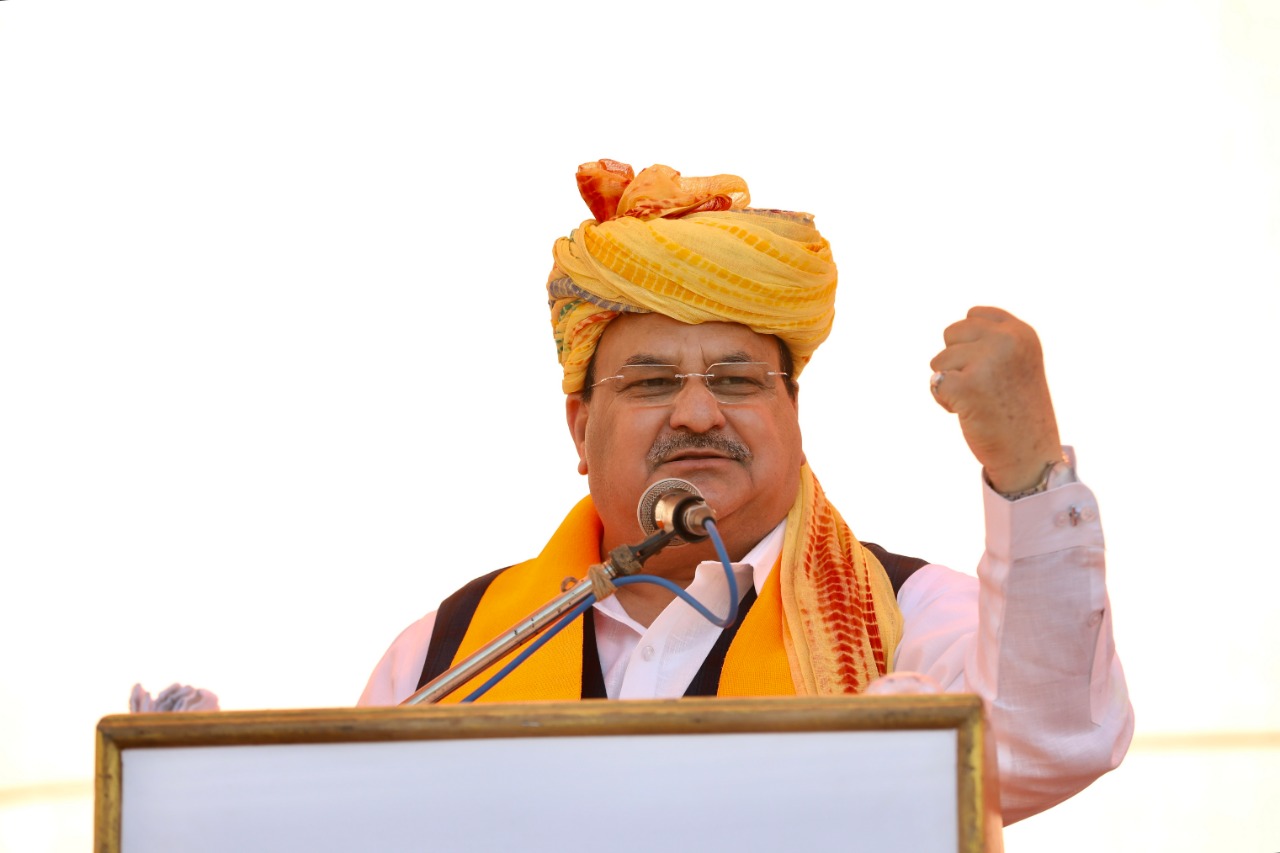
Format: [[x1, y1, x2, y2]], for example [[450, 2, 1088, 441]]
[[444, 466, 902, 703]]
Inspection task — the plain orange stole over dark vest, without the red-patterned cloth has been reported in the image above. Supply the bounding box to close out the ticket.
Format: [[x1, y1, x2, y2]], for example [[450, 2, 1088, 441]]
[[442, 497, 795, 704]]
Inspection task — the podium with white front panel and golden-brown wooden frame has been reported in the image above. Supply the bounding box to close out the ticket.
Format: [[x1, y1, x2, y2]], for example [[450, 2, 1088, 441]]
[[95, 695, 1001, 853]]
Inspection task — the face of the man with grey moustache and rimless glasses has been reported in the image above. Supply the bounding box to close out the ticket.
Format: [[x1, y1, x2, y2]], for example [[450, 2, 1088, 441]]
[[567, 314, 804, 558]]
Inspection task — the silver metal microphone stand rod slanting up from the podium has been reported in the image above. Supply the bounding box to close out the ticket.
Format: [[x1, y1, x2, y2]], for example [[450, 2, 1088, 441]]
[[401, 529, 676, 704]]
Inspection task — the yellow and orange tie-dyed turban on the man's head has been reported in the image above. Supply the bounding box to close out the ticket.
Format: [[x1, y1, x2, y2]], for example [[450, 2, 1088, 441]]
[[547, 160, 836, 393]]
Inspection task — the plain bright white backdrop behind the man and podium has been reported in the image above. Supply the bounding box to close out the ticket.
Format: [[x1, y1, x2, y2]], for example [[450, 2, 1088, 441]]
[[0, 0, 1280, 853]]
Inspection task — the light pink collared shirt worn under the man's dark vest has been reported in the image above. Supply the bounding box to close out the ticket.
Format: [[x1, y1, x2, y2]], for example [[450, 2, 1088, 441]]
[[360, 461, 1133, 824]]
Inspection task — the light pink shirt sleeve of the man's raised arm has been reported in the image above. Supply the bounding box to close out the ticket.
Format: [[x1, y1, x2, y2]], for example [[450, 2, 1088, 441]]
[[895, 466, 1133, 824]]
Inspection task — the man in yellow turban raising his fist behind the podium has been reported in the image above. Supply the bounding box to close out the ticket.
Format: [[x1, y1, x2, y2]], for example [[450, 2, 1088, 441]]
[[361, 160, 1133, 822]]
